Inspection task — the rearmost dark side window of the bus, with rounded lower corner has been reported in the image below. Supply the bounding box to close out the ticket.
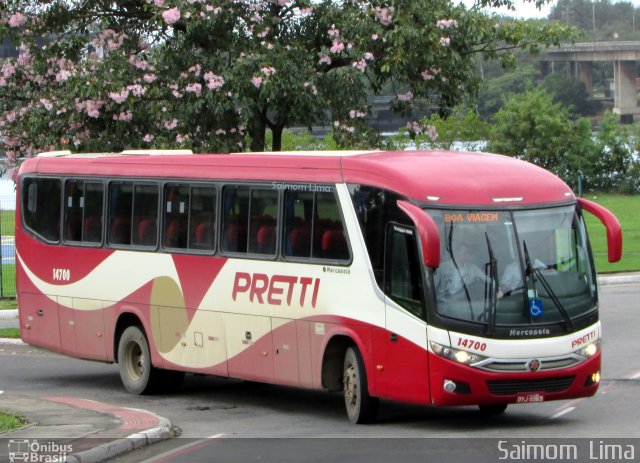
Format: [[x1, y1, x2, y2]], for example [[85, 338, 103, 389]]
[[22, 178, 62, 241]]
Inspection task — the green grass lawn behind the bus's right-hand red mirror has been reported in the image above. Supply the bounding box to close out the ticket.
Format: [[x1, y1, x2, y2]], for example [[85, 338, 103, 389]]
[[584, 193, 640, 273]]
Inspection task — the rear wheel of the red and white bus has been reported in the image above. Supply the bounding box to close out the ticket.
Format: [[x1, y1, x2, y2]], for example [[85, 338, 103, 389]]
[[118, 326, 160, 394]]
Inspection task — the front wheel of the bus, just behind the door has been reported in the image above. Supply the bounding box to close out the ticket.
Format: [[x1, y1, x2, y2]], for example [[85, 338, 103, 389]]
[[342, 347, 378, 424]]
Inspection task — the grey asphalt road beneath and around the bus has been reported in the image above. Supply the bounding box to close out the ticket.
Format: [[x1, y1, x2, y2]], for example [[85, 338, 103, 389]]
[[0, 284, 640, 462]]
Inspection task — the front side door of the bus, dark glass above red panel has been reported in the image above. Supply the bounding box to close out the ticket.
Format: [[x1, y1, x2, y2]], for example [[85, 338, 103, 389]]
[[375, 223, 430, 403]]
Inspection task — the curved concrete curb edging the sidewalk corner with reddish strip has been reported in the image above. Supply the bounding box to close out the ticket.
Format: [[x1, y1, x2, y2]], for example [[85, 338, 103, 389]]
[[66, 416, 176, 463]]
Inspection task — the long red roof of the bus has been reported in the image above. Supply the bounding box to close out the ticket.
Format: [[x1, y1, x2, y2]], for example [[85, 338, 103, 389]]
[[20, 150, 575, 206]]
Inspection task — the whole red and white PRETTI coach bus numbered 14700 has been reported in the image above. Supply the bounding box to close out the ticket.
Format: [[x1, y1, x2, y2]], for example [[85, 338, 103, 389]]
[[16, 151, 622, 423]]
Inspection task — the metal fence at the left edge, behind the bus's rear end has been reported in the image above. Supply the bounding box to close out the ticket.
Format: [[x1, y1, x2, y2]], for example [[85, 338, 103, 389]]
[[0, 195, 16, 298]]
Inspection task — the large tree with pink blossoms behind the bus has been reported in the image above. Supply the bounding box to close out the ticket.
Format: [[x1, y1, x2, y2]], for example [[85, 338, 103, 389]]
[[0, 0, 568, 176]]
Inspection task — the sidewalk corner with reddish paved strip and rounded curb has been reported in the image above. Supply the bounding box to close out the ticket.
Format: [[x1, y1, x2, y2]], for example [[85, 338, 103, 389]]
[[0, 394, 176, 463]]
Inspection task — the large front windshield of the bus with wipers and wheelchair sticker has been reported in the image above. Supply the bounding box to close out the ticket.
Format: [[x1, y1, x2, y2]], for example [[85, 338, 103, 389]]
[[427, 206, 597, 329]]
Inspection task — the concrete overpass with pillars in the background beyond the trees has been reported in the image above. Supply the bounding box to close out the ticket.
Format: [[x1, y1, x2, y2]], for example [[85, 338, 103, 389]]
[[541, 41, 640, 122]]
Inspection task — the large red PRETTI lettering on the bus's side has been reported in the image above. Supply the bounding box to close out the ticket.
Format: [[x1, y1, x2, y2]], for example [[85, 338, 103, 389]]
[[231, 272, 320, 308]]
